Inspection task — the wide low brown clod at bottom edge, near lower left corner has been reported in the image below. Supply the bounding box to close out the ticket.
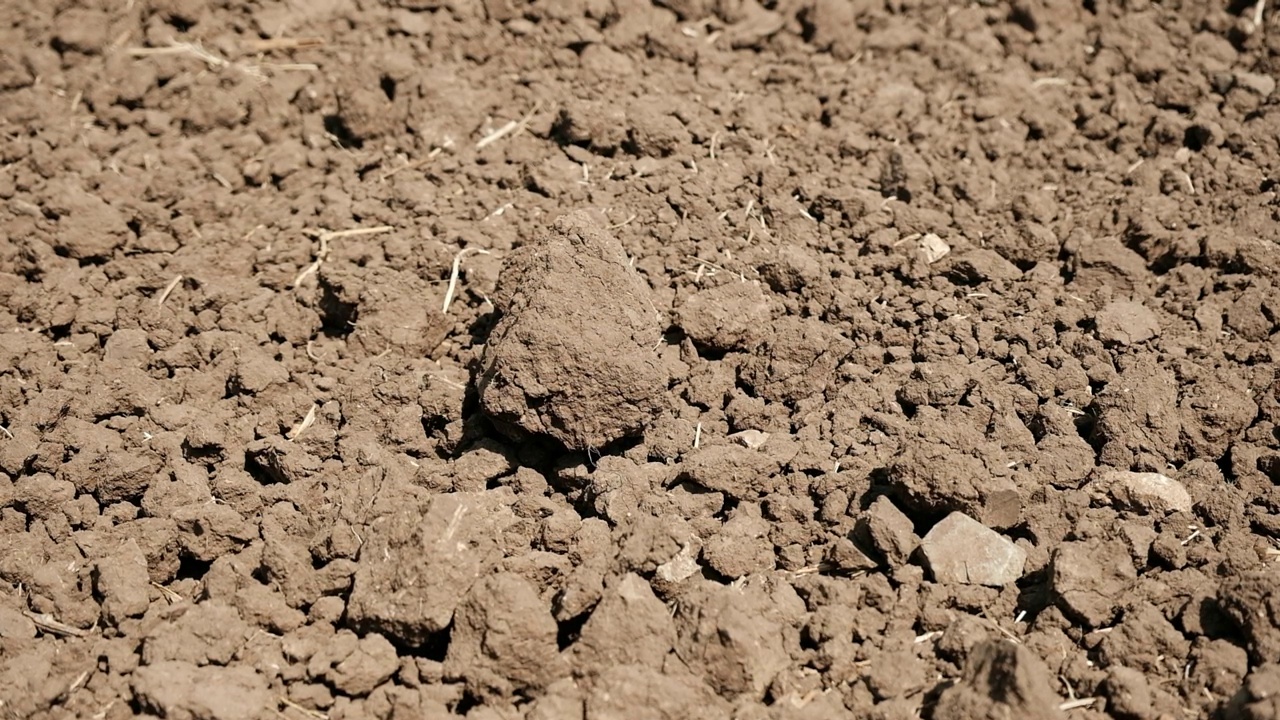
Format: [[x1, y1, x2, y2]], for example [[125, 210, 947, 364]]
[[131, 661, 275, 720]]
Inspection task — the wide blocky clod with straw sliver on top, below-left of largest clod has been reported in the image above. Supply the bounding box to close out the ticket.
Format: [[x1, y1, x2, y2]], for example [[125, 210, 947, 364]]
[[347, 491, 516, 644]]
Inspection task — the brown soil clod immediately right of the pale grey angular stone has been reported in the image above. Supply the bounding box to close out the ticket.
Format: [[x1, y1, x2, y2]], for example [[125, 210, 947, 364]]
[[1051, 541, 1138, 628]]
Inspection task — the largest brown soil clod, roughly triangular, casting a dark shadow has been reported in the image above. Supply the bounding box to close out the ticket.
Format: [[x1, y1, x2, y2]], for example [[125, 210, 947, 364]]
[[476, 213, 668, 450]]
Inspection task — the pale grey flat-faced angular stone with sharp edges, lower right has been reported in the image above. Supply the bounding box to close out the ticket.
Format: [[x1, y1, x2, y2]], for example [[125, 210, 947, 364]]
[[920, 512, 1027, 587]]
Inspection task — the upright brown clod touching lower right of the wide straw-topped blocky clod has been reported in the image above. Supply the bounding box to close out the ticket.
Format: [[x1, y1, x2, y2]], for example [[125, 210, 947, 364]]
[[444, 573, 567, 698]]
